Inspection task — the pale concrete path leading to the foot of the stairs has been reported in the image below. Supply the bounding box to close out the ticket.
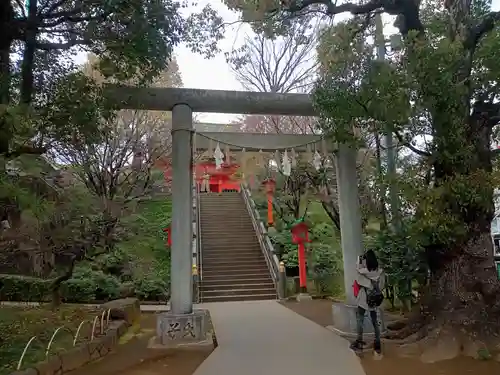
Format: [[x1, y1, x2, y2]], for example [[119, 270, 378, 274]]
[[194, 301, 365, 375]]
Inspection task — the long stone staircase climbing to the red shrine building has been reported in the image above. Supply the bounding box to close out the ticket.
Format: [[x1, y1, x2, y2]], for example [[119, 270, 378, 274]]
[[200, 192, 277, 302]]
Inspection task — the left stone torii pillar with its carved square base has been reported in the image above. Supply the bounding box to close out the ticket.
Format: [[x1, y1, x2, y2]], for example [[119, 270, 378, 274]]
[[151, 104, 213, 347]]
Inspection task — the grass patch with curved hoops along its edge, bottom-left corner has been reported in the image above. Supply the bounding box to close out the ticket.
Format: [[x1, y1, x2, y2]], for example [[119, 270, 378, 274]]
[[0, 306, 98, 375]]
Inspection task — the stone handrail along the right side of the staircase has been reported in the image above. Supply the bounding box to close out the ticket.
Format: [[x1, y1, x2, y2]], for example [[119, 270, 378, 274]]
[[241, 183, 284, 298]]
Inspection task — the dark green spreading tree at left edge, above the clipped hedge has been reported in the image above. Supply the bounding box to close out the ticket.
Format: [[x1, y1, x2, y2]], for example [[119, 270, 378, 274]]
[[0, 169, 108, 307]]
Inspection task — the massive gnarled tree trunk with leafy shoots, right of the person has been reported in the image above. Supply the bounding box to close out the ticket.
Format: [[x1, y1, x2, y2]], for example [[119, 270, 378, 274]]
[[412, 113, 500, 337]]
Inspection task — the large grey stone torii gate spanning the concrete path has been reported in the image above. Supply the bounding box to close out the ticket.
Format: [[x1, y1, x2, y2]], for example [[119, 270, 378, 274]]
[[106, 86, 363, 343]]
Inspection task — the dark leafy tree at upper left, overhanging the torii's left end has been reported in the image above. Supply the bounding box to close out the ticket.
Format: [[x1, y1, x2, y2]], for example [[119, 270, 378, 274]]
[[0, 0, 222, 160]]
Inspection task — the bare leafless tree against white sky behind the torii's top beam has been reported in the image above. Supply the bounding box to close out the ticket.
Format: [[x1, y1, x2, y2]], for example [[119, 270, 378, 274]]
[[226, 19, 320, 134]]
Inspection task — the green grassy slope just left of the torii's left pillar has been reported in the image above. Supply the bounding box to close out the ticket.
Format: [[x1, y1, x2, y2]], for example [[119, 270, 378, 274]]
[[117, 198, 172, 276]]
